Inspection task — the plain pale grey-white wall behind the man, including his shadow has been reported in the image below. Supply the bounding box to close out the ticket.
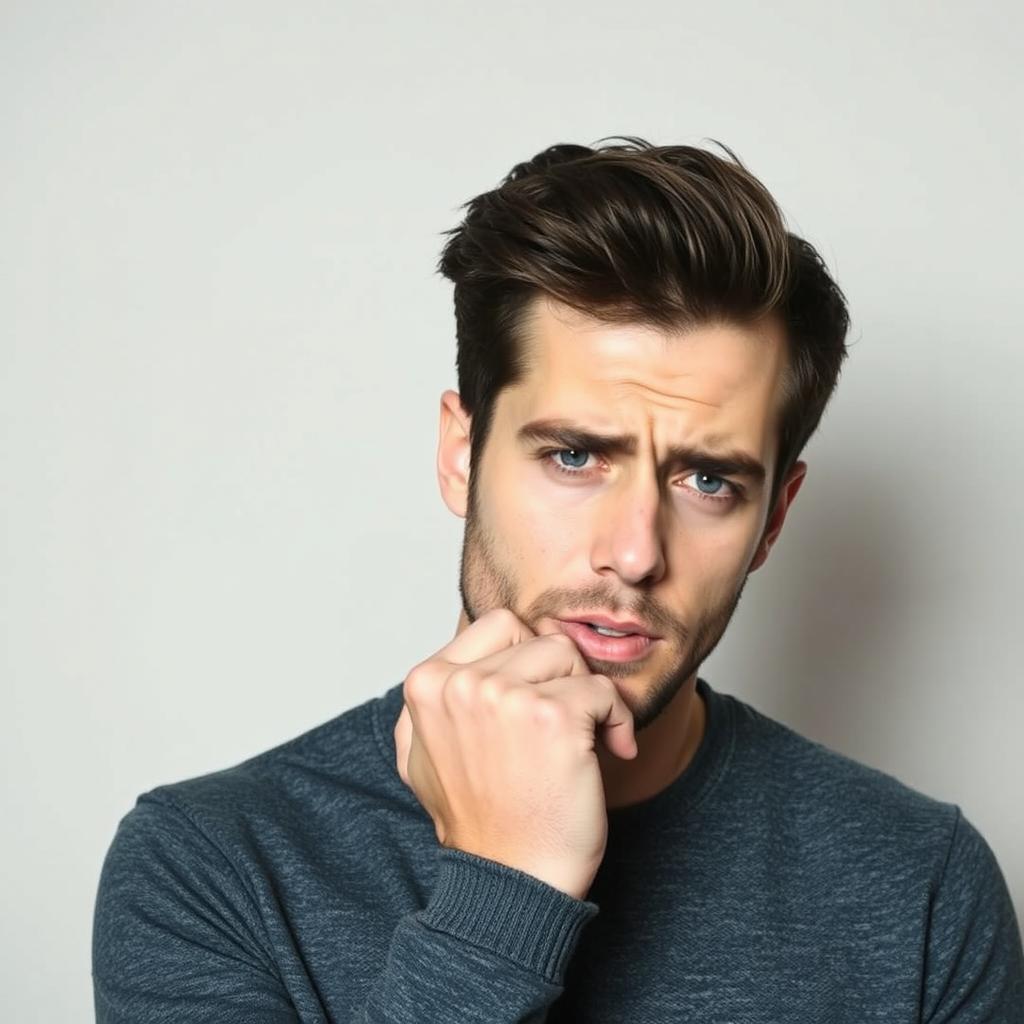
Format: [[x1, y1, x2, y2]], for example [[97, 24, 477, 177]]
[[0, 0, 1024, 1021]]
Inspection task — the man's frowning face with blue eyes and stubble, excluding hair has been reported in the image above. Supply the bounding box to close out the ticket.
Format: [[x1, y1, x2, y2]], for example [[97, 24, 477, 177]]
[[442, 299, 803, 730]]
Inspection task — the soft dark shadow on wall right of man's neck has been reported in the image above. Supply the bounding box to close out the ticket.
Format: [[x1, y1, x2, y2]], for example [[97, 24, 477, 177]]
[[720, 454, 934, 770]]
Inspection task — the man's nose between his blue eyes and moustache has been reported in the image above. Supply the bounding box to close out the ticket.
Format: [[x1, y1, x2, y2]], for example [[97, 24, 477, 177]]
[[591, 473, 666, 587]]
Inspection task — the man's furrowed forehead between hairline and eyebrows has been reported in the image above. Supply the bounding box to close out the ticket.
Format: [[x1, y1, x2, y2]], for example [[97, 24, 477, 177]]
[[496, 298, 786, 461]]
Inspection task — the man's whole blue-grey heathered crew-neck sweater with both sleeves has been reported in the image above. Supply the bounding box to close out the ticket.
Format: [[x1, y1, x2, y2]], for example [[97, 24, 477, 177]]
[[93, 680, 1024, 1024]]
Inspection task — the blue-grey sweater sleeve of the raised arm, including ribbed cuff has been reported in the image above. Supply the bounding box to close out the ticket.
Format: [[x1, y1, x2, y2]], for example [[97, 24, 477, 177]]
[[92, 797, 598, 1024]]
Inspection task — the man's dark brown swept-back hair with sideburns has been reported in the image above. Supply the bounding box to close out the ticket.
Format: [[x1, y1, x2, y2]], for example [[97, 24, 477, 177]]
[[437, 136, 849, 505]]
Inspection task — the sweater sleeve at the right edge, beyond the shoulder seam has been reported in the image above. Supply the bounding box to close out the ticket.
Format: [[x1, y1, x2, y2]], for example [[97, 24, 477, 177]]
[[922, 808, 1024, 1024]]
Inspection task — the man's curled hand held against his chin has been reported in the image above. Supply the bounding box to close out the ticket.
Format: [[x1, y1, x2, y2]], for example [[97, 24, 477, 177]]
[[394, 608, 637, 899]]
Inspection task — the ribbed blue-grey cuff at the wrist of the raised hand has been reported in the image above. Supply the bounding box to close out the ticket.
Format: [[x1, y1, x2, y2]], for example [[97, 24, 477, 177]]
[[419, 848, 599, 985]]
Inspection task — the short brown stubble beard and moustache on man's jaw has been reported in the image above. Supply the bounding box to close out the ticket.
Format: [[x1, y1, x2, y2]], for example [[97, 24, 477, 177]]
[[459, 476, 748, 732]]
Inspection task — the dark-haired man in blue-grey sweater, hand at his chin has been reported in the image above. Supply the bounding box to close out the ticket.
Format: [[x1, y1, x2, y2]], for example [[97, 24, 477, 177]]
[[93, 139, 1024, 1024]]
